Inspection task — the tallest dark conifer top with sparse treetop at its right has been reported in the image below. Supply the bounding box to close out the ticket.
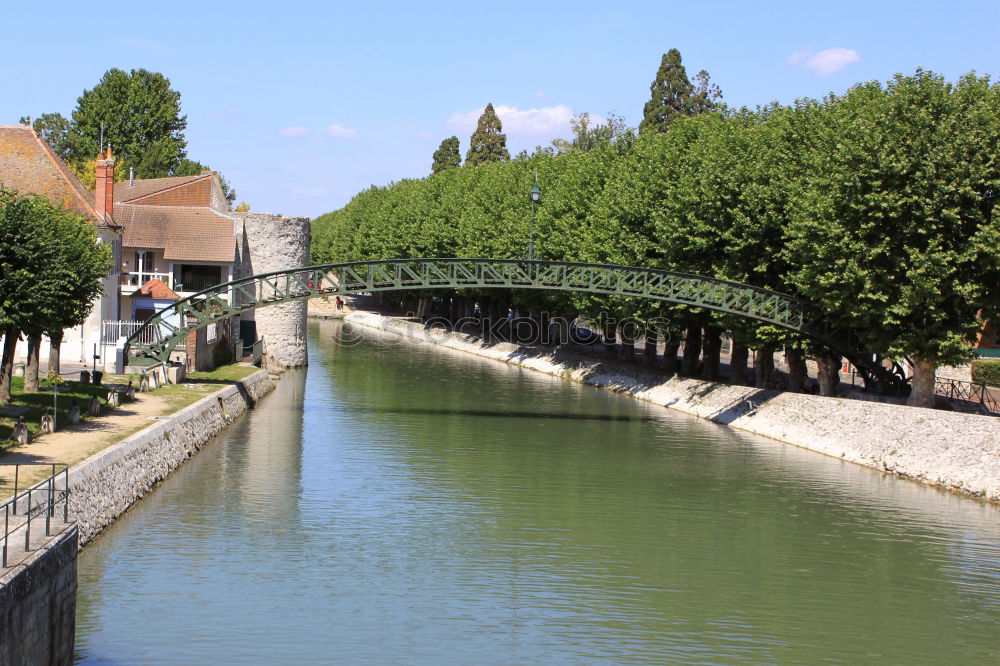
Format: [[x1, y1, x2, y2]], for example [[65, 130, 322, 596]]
[[639, 49, 722, 132]]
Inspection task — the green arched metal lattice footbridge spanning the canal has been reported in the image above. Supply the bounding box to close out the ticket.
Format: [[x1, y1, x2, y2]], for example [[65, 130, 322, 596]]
[[125, 259, 907, 391]]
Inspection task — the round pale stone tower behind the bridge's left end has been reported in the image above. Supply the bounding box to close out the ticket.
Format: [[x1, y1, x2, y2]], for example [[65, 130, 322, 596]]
[[234, 213, 311, 368]]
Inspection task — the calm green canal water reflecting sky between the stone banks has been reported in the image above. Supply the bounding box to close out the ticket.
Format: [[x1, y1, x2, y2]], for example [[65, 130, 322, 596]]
[[77, 322, 1000, 664]]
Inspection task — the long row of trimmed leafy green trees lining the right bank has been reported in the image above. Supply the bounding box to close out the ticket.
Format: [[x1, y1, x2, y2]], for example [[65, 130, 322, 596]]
[[313, 70, 1000, 405]]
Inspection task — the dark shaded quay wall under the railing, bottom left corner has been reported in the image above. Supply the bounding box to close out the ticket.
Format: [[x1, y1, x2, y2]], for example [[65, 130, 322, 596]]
[[0, 527, 77, 664]]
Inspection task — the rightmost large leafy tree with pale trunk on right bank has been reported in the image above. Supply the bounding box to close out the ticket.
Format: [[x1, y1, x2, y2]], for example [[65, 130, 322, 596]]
[[783, 70, 1000, 407]]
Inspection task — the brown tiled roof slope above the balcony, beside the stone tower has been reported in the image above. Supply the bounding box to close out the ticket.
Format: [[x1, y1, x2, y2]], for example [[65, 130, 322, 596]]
[[114, 203, 236, 263]]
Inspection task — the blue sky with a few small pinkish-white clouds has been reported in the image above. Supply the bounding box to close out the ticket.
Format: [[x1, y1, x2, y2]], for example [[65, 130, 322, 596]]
[[0, 0, 1000, 216]]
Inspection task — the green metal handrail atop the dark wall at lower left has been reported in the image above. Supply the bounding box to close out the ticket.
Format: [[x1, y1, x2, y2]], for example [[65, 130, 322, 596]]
[[0, 463, 69, 568]]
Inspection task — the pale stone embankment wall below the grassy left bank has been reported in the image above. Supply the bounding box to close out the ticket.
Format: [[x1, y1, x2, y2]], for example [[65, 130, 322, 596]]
[[69, 370, 274, 548]]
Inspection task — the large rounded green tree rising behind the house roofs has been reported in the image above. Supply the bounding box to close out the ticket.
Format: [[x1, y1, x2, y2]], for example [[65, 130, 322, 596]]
[[70, 69, 187, 178]]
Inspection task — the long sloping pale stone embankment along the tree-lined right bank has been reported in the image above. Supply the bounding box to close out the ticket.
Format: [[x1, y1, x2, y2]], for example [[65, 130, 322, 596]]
[[344, 312, 1000, 500]]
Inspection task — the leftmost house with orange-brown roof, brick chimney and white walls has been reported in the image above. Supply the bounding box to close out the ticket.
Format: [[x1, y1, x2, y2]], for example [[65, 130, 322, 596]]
[[0, 125, 122, 363]]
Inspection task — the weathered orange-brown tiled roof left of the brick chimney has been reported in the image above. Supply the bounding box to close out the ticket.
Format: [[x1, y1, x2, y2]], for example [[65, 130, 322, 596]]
[[0, 125, 99, 220]]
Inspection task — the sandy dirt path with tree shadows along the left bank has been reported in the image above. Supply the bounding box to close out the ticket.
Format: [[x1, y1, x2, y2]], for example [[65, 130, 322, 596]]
[[0, 393, 169, 497]]
